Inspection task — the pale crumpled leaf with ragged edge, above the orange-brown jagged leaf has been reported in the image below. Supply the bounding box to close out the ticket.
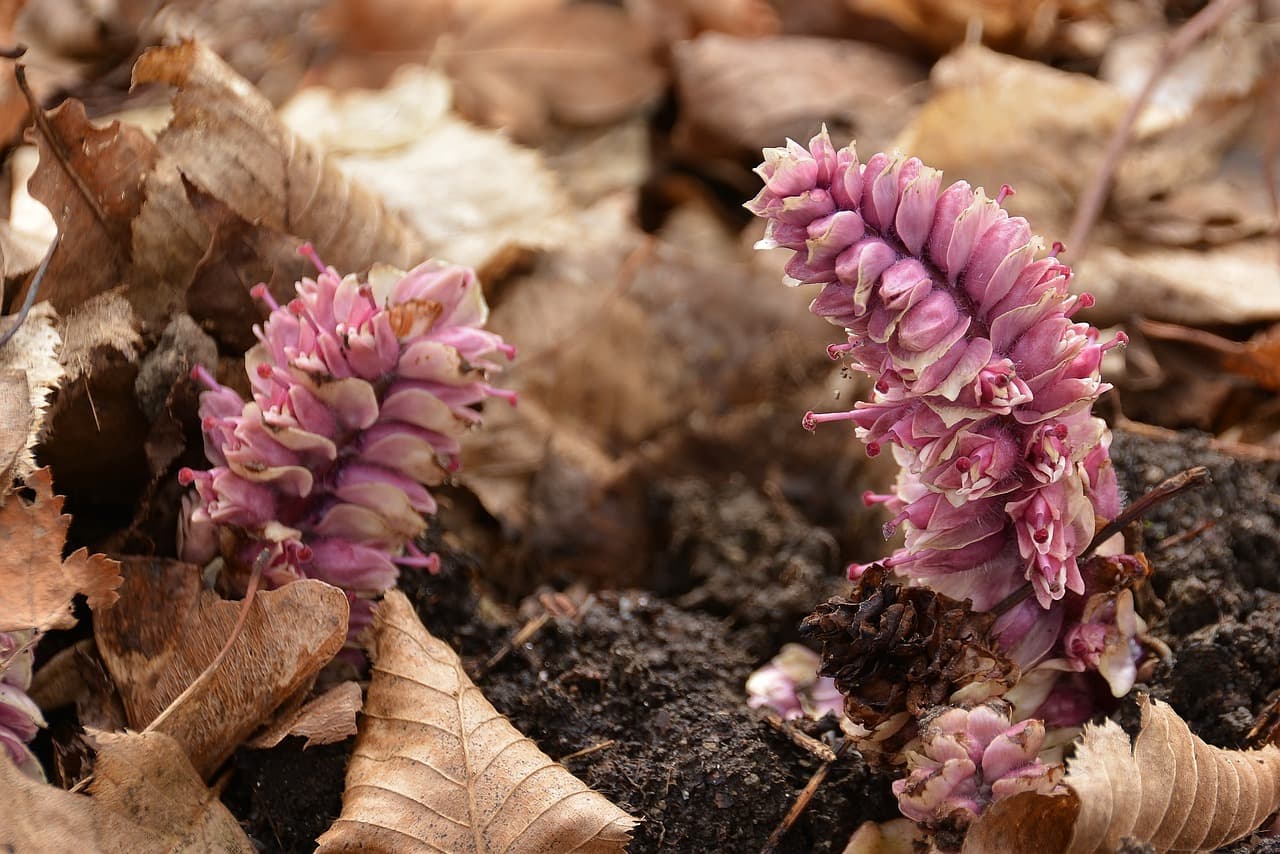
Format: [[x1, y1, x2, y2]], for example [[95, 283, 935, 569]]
[[0, 302, 65, 486]]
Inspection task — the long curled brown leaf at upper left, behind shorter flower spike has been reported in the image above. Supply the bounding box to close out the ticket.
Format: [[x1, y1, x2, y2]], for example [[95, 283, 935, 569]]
[[133, 41, 424, 270]]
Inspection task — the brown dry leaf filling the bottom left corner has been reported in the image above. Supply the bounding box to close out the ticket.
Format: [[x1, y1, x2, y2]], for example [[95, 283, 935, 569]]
[[0, 732, 256, 854]]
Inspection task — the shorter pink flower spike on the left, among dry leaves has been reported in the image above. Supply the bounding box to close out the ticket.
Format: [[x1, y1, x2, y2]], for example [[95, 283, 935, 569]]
[[179, 246, 516, 634]]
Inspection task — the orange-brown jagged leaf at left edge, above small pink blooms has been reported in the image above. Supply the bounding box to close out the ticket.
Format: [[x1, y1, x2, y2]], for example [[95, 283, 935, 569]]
[[0, 469, 120, 631]]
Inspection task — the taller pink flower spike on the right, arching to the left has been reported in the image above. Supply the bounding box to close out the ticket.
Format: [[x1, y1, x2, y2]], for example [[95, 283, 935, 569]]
[[748, 132, 1143, 725]]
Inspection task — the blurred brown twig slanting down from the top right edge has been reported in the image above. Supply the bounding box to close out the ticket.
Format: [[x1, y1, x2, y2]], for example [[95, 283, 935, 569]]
[[1066, 0, 1245, 260]]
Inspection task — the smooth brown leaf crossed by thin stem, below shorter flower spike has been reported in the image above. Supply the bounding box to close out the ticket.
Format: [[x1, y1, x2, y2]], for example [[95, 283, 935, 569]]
[[93, 557, 348, 776]]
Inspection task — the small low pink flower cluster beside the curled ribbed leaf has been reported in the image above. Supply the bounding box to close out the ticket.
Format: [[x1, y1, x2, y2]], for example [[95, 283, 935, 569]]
[[893, 700, 1062, 831]]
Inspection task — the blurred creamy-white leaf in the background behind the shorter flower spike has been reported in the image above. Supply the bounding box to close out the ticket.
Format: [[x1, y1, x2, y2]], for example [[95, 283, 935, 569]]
[[288, 68, 573, 271]]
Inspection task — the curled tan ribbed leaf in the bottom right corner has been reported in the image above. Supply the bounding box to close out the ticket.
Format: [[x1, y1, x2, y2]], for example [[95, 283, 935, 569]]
[[964, 697, 1280, 854]]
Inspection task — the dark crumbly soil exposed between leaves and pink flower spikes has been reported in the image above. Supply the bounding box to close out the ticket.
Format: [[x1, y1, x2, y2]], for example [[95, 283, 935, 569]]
[[225, 433, 1280, 851]]
